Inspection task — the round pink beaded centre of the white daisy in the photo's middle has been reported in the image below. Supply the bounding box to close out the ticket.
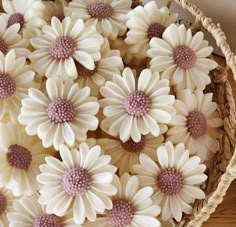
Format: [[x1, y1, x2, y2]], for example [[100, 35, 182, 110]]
[[124, 91, 150, 117]]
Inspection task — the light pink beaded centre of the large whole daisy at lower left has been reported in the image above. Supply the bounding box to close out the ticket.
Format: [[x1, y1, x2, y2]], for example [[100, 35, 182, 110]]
[[62, 168, 92, 196]]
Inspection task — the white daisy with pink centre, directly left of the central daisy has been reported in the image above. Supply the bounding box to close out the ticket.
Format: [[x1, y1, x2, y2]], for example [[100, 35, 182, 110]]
[[19, 78, 99, 150]]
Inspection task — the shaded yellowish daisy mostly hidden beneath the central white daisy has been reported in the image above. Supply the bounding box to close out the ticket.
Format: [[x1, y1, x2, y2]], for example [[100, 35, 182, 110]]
[[97, 132, 164, 176]]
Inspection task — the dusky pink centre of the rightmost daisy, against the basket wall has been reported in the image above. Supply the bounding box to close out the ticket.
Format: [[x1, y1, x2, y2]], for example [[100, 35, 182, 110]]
[[186, 111, 207, 139]]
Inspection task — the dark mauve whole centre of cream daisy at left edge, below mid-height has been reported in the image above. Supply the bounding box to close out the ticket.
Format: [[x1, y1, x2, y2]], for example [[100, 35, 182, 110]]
[[7, 144, 32, 170]]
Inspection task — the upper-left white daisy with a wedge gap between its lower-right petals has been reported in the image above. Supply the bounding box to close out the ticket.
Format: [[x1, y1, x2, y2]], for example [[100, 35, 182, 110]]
[[29, 17, 103, 80]]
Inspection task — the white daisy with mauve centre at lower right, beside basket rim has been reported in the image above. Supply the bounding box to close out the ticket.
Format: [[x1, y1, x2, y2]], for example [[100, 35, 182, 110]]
[[133, 142, 207, 222]]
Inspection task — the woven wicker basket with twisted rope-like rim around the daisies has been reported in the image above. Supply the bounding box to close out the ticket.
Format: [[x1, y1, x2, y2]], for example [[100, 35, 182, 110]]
[[133, 0, 236, 227]]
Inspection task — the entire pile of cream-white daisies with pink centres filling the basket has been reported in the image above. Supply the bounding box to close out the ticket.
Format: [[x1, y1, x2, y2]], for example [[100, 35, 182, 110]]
[[0, 0, 223, 227]]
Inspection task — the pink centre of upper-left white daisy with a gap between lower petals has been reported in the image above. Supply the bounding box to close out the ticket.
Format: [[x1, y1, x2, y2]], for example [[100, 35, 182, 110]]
[[49, 36, 76, 61]]
